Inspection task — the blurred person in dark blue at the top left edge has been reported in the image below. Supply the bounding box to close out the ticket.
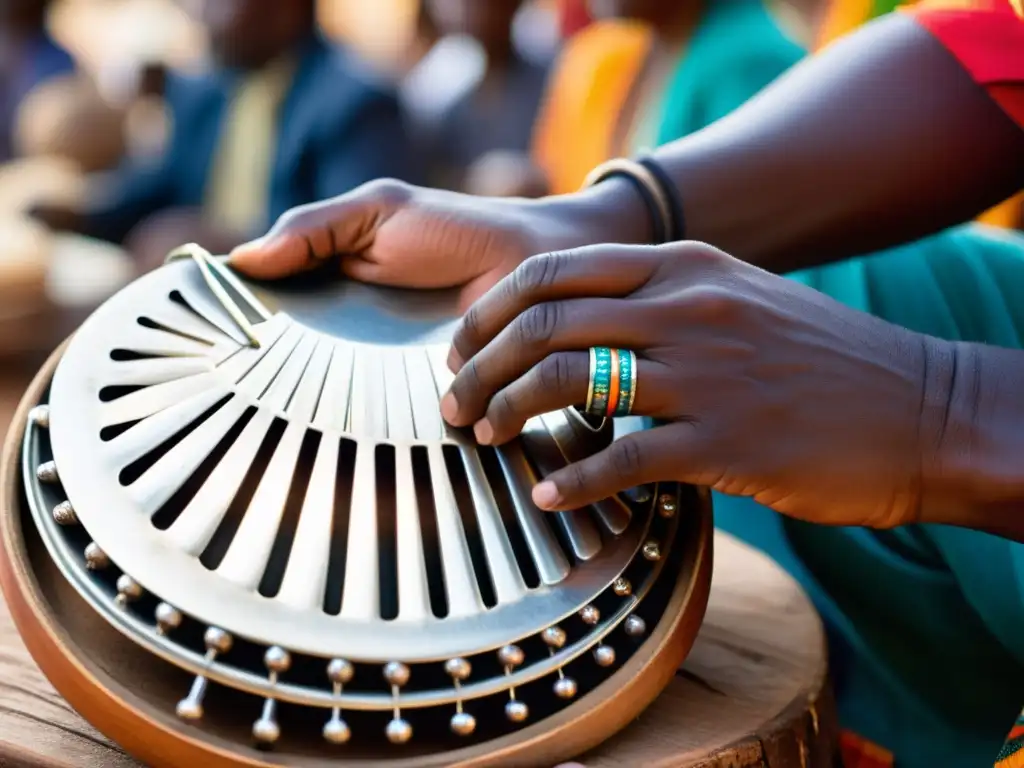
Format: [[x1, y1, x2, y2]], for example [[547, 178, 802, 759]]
[[0, 0, 75, 162]]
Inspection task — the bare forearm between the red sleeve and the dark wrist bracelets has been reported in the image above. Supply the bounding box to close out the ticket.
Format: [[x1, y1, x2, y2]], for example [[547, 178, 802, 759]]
[[552, 14, 1024, 272]]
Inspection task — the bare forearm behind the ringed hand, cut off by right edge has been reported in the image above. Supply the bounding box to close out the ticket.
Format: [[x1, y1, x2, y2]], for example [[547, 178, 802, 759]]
[[922, 339, 1024, 542]]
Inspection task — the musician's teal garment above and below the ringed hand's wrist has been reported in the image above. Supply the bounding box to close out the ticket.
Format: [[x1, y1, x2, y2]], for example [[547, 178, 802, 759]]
[[715, 225, 1024, 768]]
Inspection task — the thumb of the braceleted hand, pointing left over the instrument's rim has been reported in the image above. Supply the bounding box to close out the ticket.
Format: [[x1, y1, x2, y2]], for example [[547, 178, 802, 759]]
[[228, 179, 411, 280]]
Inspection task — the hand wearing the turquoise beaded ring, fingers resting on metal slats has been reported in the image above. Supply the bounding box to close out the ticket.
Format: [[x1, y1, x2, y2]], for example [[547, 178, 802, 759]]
[[441, 243, 943, 527]]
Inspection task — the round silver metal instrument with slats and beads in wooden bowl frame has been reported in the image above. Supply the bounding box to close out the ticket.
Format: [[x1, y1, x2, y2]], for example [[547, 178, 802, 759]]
[[0, 247, 712, 768]]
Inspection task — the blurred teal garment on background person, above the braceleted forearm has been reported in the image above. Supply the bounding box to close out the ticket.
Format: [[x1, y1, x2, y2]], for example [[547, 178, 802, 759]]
[[657, 0, 806, 146]]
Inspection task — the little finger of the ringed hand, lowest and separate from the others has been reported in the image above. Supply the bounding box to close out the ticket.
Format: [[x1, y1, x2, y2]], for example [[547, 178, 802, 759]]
[[534, 422, 696, 511]]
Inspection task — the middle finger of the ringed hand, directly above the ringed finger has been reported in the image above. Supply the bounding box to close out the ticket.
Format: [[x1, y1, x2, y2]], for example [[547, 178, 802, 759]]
[[441, 299, 653, 427]]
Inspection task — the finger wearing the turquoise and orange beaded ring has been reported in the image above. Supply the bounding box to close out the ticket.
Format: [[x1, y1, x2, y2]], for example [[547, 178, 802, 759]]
[[473, 352, 667, 445]]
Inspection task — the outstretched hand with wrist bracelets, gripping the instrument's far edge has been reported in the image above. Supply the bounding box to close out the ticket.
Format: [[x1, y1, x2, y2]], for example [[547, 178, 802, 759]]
[[230, 180, 646, 306]]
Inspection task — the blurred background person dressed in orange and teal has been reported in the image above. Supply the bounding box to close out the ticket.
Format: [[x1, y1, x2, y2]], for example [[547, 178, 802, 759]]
[[534, 0, 805, 195]]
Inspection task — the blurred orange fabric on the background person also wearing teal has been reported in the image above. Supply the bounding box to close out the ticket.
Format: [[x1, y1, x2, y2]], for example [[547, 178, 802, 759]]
[[534, 22, 651, 195]]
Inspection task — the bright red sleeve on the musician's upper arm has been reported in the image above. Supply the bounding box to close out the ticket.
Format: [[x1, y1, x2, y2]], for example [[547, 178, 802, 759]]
[[906, 0, 1024, 127]]
